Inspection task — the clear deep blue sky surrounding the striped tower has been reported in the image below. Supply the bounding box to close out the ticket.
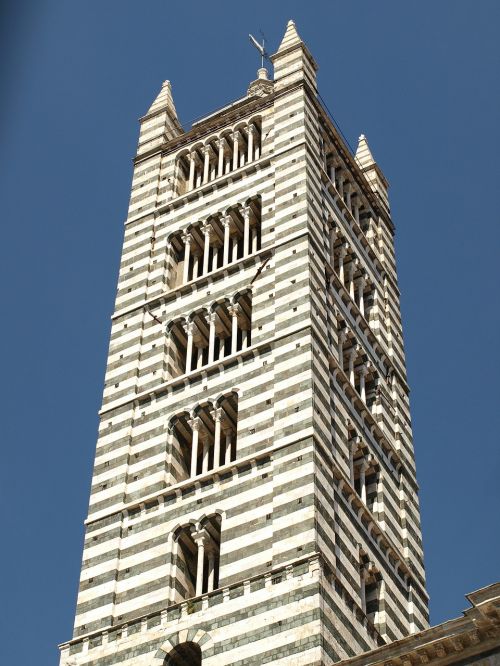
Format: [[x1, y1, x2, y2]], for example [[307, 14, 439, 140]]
[[0, 0, 500, 666]]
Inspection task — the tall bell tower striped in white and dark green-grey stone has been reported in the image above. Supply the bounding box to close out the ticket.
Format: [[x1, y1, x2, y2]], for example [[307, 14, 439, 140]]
[[61, 21, 427, 666]]
